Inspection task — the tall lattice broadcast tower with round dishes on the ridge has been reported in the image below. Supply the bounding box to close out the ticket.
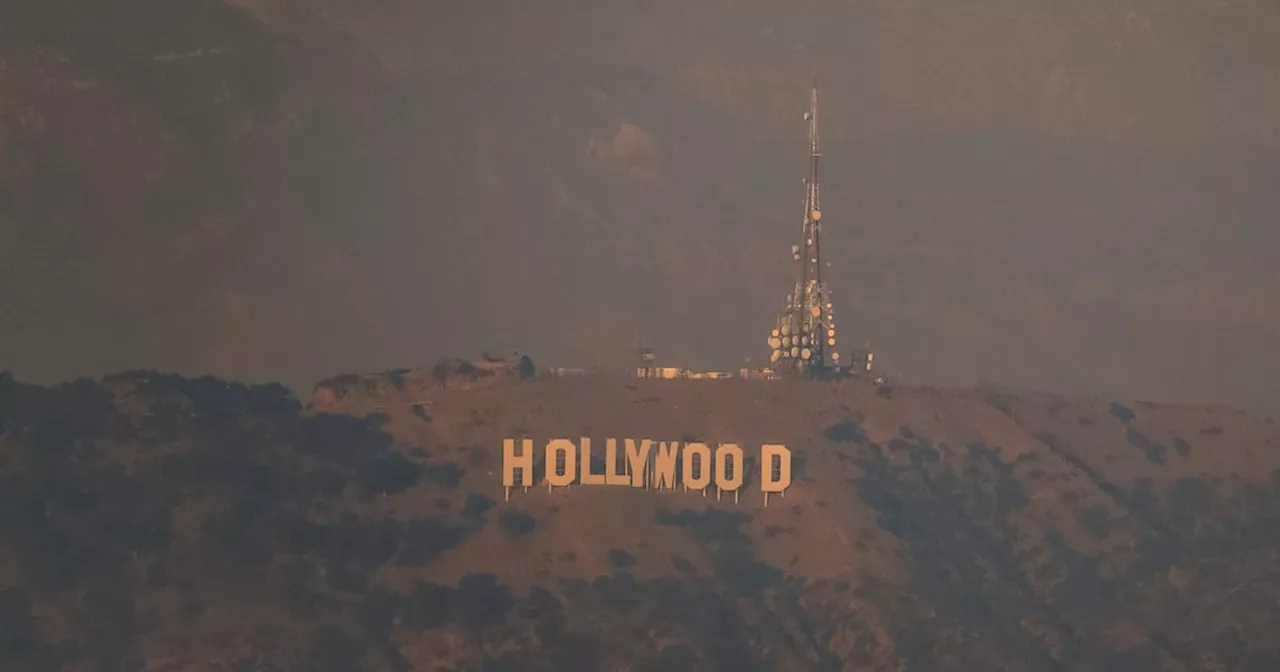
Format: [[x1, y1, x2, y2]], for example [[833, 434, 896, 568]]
[[768, 81, 840, 375]]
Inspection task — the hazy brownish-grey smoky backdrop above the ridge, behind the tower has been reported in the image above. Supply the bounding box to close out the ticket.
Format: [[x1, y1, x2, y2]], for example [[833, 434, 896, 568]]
[[0, 0, 1280, 412]]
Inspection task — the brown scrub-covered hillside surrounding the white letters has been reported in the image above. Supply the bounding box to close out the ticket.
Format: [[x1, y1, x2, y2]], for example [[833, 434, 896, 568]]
[[0, 367, 1280, 672]]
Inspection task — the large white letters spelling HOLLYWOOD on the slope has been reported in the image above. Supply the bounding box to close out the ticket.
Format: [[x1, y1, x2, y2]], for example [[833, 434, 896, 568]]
[[502, 438, 791, 506]]
